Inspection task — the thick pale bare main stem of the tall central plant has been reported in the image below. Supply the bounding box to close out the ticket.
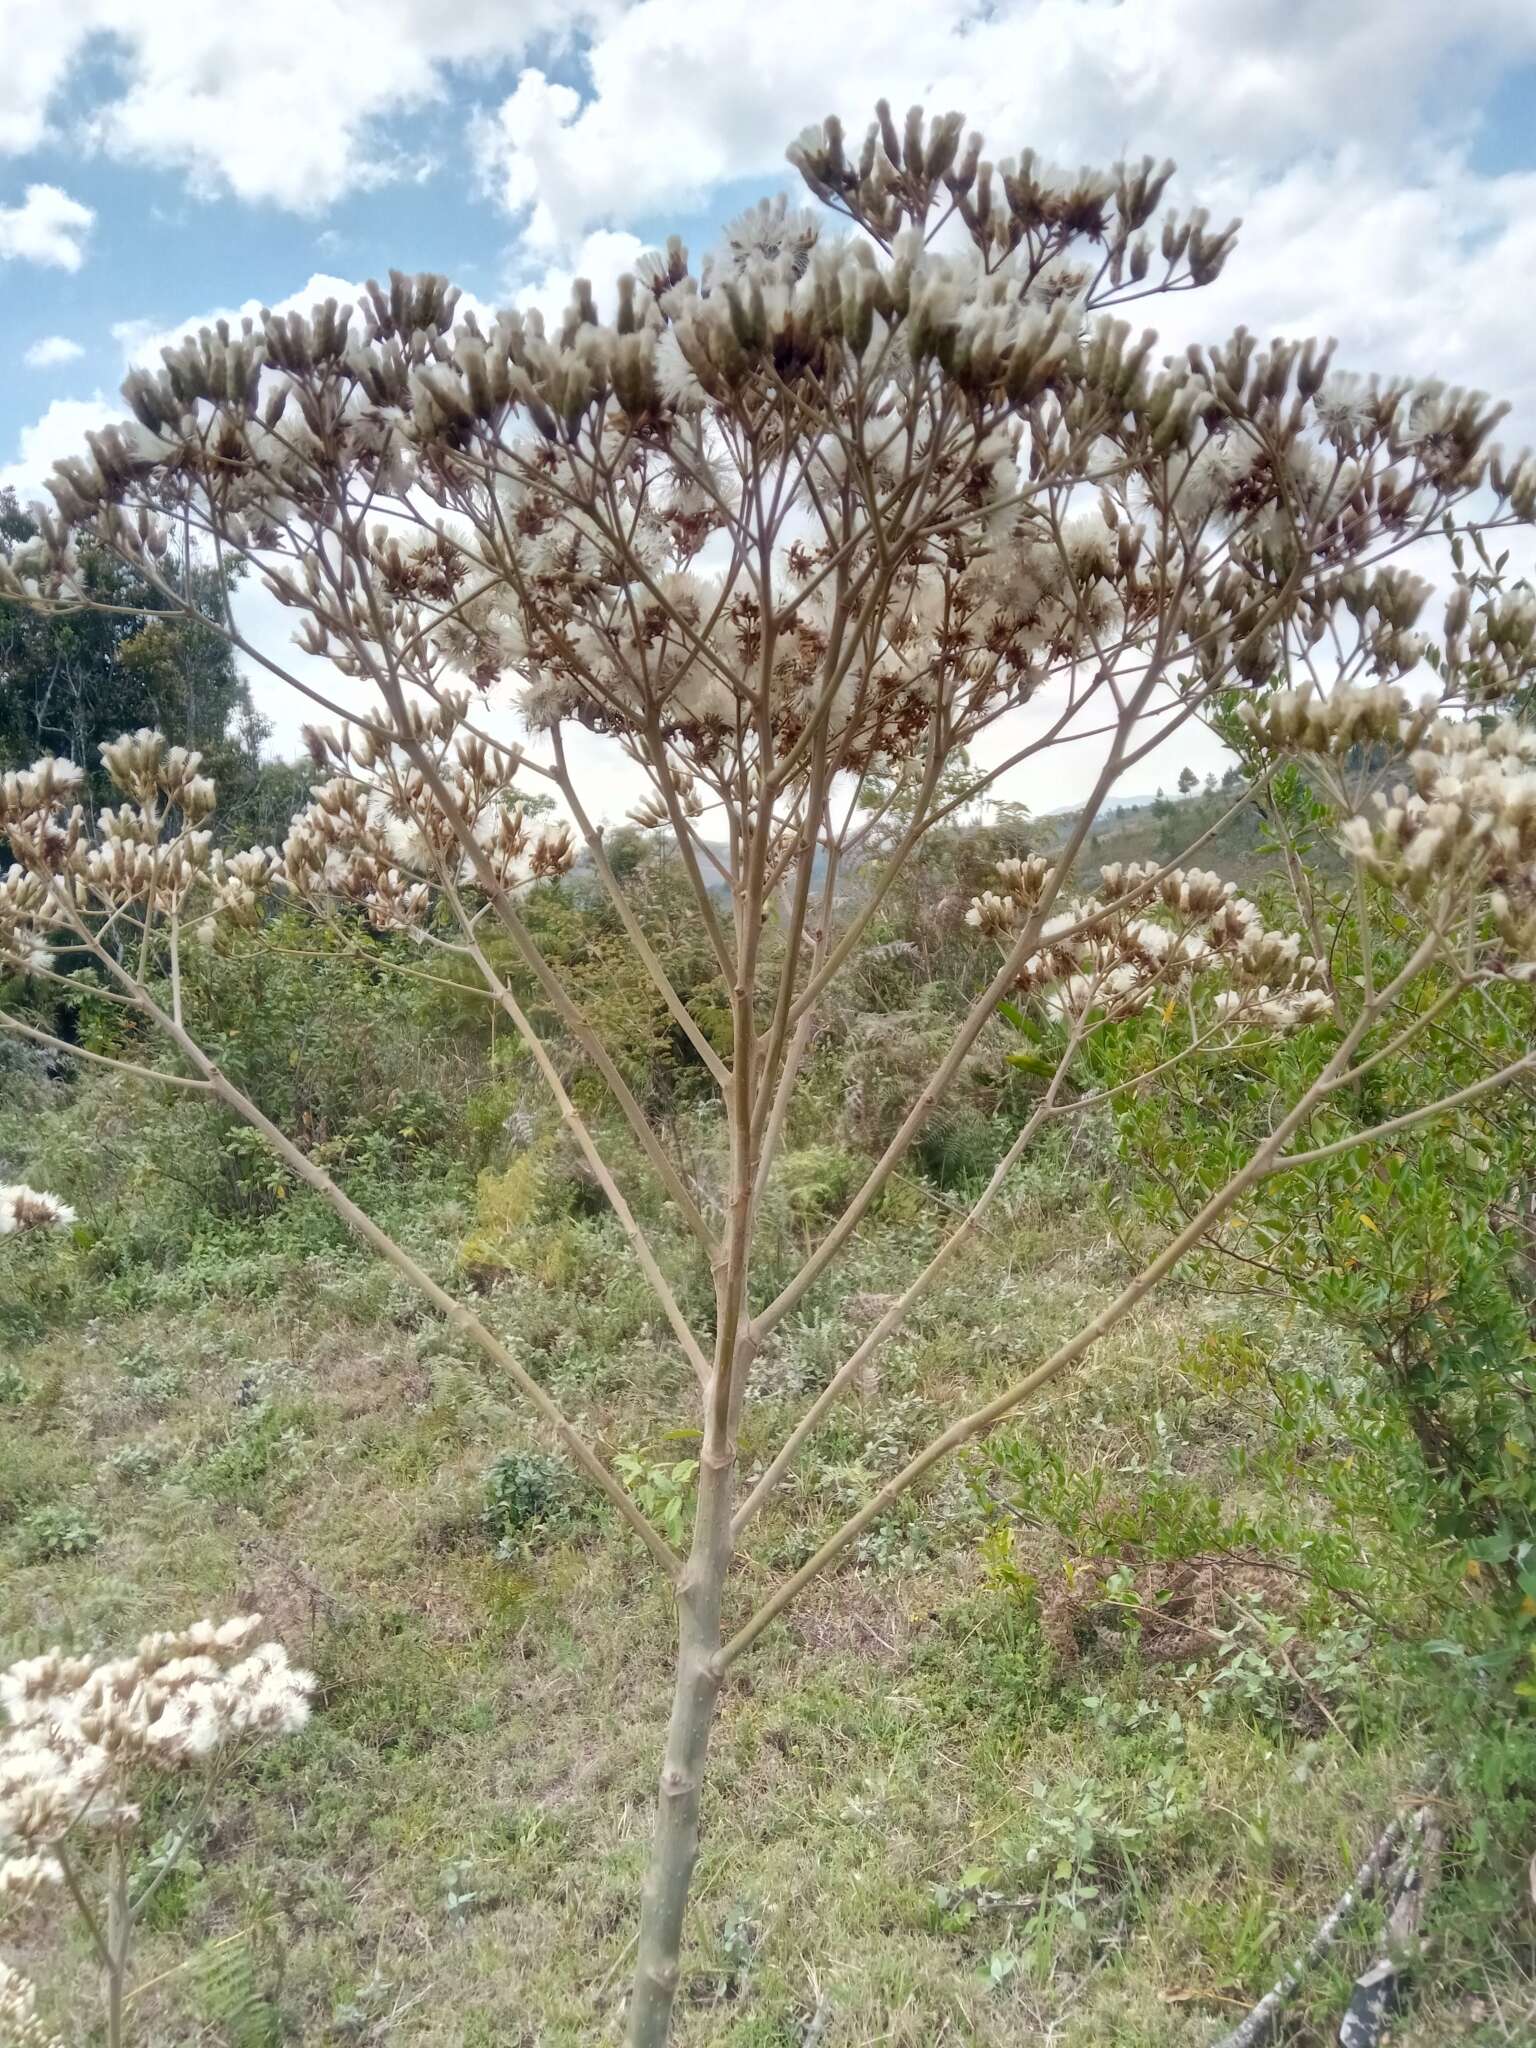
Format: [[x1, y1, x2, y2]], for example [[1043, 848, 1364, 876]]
[[629, 1425, 735, 2048]]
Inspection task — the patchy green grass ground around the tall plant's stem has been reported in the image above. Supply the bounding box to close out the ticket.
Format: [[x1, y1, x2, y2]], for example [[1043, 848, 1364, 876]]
[[0, 1130, 1536, 2048]]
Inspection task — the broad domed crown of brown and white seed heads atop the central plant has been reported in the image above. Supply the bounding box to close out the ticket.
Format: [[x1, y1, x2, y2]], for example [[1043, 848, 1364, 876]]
[[6, 106, 1536, 839]]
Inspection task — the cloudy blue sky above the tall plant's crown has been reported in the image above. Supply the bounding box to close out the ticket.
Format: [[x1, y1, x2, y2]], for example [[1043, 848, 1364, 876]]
[[0, 0, 1536, 806]]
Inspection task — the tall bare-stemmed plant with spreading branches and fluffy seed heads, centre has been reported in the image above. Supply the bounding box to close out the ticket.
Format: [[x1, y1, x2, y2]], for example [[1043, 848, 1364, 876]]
[[0, 106, 1536, 2048]]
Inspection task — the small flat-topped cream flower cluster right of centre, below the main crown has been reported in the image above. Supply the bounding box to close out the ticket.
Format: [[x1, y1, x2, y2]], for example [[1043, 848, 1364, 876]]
[[967, 854, 1333, 1030]]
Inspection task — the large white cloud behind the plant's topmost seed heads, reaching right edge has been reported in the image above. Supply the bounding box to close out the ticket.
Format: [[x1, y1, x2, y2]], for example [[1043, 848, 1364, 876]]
[[471, 0, 1536, 452]]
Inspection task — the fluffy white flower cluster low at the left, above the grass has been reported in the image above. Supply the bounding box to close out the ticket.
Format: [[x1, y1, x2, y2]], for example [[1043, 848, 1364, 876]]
[[0, 1614, 315, 1898]]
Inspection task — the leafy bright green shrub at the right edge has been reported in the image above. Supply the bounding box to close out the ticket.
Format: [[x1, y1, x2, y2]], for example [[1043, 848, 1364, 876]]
[[1090, 774, 1536, 1604]]
